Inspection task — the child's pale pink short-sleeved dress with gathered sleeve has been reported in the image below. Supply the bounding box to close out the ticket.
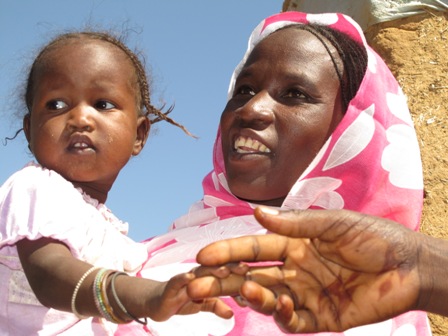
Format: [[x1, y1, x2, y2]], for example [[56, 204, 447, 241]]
[[0, 163, 147, 336]]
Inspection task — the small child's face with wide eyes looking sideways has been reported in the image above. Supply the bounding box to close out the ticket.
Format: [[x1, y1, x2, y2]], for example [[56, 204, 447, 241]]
[[24, 39, 149, 197]]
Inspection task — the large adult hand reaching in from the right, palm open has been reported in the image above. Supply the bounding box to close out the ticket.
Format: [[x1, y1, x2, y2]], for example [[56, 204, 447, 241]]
[[188, 207, 420, 333]]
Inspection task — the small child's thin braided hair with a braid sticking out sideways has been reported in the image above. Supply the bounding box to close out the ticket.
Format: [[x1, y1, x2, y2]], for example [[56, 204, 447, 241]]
[[24, 31, 192, 136]]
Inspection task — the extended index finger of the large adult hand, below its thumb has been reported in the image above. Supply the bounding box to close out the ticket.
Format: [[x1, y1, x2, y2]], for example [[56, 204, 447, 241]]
[[196, 235, 288, 266]]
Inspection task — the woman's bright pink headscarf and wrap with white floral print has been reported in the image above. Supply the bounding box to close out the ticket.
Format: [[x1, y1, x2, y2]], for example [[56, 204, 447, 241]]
[[128, 12, 431, 336]]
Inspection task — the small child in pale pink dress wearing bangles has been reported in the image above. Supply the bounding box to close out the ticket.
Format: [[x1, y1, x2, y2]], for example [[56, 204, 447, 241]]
[[0, 32, 232, 335]]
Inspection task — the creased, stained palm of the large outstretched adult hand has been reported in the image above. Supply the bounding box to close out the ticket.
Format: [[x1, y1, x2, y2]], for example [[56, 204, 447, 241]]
[[262, 232, 418, 332]]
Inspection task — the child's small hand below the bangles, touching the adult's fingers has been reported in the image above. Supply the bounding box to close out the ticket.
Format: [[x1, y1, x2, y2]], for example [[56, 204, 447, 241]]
[[148, 273, 233, 321]]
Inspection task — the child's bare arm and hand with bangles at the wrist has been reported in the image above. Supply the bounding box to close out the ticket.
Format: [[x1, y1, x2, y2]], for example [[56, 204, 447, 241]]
[[17, 238, 232, 322]]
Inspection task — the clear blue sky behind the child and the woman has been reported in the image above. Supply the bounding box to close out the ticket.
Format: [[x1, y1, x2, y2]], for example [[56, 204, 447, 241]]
[[0, 0, 283, 240]]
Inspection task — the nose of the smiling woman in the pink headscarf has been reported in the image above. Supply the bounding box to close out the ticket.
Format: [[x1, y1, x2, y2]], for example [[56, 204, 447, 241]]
[[236, 91, 275, 128]]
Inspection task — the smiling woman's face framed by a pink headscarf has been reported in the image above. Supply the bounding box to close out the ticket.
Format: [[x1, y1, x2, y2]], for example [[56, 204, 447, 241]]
[[220, 28, 344, 206]]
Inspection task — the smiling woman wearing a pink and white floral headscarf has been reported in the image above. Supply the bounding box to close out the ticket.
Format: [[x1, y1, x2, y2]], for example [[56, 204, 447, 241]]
[[132, 12, 430, 335]]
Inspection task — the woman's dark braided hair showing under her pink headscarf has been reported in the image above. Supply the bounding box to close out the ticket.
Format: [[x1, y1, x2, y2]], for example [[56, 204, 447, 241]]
[[279, 24, 367, 110]]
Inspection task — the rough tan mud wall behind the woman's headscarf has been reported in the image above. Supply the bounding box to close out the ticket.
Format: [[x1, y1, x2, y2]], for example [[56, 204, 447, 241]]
[[366, 12, 448, 336]]
